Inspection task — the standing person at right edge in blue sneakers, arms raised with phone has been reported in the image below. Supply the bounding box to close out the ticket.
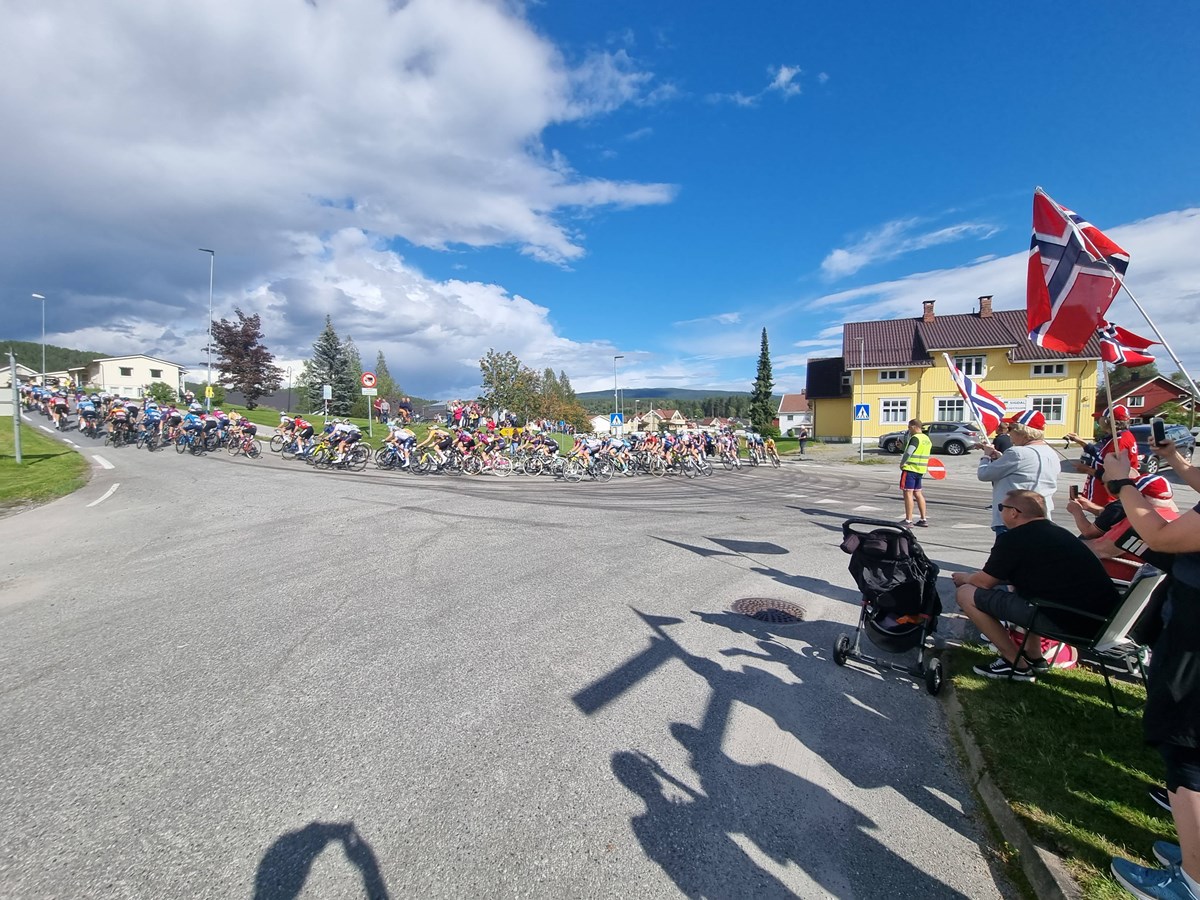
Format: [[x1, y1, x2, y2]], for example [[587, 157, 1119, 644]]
[[1102, 442, 1200, 898]]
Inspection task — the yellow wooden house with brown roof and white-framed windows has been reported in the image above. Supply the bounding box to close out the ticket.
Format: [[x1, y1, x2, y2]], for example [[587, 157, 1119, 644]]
[[808, 296, 1100, 446]]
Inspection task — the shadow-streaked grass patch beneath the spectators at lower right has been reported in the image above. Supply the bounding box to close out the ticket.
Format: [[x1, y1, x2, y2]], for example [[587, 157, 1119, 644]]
[[950, 647, 1176, 900]]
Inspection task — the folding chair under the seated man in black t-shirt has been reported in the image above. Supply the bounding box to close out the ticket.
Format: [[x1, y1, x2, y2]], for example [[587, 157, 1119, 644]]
[[1016, 565, 1166, 715]]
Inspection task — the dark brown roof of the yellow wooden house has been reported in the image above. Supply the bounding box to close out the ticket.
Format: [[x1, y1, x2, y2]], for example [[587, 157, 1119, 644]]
[[840, 310, 1100, 369]]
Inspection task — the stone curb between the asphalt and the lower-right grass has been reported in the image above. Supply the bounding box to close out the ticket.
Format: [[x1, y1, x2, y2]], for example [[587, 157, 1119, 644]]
[[946, 684, 1084, 900]]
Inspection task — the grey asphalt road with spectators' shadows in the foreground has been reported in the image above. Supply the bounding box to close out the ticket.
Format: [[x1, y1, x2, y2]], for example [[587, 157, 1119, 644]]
[[0, 424, 1161, 898]]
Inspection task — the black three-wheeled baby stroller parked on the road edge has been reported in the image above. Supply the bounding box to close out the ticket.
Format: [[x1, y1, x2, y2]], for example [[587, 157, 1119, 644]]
[[833, 518, 942, 695]]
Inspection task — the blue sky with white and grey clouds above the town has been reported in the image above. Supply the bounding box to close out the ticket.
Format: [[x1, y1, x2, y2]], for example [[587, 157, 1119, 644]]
[[0, 0, 1200, 400]]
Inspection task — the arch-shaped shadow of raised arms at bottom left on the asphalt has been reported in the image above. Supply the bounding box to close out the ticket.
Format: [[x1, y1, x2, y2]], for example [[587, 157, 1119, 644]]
[[254, 822, 388, 900]]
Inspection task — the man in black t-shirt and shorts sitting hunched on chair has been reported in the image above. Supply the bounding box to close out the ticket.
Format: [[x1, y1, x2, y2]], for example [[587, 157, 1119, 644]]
[[952, 491, 1121, 682]]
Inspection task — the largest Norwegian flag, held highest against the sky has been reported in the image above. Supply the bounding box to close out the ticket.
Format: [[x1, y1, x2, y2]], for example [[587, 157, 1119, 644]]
[[1025, 187, 1129, 353]]
